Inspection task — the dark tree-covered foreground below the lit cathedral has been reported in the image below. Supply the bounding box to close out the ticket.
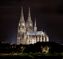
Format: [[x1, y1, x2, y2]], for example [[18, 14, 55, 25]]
[[0, 42, 63, 59]]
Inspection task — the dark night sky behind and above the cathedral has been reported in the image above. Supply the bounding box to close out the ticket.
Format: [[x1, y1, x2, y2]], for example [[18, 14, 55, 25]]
[[0, 0, 63, 43]]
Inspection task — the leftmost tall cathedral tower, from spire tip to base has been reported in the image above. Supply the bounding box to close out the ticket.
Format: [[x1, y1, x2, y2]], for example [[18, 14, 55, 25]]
[[17, 7, 26, 44]]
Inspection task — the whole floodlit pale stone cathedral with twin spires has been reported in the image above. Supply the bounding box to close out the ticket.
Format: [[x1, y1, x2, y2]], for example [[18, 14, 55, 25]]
[[17, 8, 49, 45]]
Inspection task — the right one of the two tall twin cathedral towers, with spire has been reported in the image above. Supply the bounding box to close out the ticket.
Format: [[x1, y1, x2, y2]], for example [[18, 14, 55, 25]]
[[26, 8, 33, 32]]
